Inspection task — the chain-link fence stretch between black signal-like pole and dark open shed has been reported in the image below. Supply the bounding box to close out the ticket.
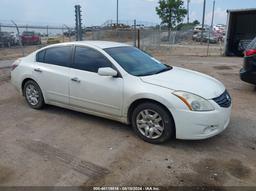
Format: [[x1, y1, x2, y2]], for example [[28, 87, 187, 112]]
[[84, 28, 224, 56]]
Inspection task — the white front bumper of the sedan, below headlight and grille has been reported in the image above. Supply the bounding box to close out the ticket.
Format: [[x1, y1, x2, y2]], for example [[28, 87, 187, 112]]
[[172, 101, 231, 140]]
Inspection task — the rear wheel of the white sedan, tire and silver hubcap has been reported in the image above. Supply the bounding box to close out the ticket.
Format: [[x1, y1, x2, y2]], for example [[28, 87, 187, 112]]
[[23, 80, 45, 110]]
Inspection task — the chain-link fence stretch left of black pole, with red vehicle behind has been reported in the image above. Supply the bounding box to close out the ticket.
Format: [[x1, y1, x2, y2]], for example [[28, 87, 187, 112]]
[[0, 20, 75, 60]]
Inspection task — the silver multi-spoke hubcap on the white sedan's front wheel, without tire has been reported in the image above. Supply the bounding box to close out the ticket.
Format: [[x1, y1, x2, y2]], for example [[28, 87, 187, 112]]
[[136, 109, 164, 139]]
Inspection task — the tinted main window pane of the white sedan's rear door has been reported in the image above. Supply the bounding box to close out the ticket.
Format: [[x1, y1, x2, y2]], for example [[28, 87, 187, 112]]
[[44, 46, 72, 67]]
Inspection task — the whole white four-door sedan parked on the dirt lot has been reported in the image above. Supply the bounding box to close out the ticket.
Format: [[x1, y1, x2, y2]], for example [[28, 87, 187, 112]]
[[11, 41, 231, 143]]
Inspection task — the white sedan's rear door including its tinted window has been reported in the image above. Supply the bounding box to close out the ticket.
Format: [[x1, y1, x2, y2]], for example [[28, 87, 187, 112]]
[[33, 46, 72, 104]]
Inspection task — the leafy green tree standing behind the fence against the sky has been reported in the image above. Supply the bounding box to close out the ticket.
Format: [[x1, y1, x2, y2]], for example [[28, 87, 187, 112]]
[[156, 0, 187, 39]]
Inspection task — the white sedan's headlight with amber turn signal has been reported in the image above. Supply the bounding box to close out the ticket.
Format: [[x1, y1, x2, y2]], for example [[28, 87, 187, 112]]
[[173, 91, 214, 111]]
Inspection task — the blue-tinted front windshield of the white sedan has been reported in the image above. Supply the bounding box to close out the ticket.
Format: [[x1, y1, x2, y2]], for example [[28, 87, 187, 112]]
[[104, 46, 172, 76]]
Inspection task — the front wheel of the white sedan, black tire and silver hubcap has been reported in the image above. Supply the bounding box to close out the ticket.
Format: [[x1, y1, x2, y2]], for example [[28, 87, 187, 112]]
[[131, 102, 175, 144]]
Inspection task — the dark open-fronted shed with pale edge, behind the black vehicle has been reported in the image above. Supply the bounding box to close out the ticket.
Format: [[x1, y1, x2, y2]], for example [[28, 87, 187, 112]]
[[225, 9, 256, 56]]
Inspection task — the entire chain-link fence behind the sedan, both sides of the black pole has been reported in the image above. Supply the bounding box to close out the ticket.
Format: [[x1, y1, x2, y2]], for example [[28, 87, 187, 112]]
[[0, 22, 223, 59]]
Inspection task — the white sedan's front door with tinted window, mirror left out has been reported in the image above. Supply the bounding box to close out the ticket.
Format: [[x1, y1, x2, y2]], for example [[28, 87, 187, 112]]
[[69, 46, 123, 116]]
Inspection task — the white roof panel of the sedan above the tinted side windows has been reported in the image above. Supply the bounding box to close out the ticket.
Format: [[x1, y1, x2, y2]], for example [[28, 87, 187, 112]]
[[45, 41, 130, 49]]
